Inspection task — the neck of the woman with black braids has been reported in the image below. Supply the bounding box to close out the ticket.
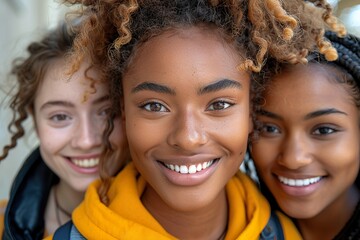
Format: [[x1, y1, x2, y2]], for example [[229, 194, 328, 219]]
[[297, 186, 360, 240]]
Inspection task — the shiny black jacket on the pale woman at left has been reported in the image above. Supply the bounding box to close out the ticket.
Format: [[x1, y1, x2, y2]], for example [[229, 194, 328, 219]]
[[2, 148, 59, 240]]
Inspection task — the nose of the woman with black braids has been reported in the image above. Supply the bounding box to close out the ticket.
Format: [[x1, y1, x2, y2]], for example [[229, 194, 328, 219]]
[[277, 134, 313, 170]]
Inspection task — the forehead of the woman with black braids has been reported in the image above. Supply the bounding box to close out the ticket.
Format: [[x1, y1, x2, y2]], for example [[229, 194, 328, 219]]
[[265, 64, 354, 112]]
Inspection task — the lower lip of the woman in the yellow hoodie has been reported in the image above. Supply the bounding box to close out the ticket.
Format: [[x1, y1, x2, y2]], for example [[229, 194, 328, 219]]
[[159, 160, 221, 186]]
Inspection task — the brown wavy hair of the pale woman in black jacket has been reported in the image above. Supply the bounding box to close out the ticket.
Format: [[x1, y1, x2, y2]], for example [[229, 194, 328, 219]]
[[0, 23, 76, 161]]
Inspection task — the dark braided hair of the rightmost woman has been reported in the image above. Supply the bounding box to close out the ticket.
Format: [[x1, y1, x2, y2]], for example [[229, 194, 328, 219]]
[[249, 32, 360, 239]]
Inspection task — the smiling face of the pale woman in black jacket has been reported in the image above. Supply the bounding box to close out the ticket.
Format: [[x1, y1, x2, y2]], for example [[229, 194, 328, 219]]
[[34, 59, 123, 192]]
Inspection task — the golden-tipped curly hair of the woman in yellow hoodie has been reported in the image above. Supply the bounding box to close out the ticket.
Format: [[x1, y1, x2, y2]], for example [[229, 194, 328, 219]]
[[64, 0, 345, 204]]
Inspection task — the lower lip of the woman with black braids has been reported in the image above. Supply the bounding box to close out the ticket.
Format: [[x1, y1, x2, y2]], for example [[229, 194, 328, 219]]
[[276, 177, 325, 197]]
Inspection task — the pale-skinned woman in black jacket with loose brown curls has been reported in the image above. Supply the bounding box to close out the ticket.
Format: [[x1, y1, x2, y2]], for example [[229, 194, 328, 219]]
[[0, 20, 125, 240]]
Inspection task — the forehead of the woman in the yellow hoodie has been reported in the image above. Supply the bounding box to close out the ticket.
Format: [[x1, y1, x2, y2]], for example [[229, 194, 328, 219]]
[[124, 27, 247, 89]]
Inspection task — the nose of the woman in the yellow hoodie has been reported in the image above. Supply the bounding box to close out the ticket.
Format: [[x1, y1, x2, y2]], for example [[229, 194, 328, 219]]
[[168, 110, 208, 151]]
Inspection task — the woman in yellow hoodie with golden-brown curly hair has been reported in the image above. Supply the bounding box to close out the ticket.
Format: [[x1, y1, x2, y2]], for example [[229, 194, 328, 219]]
[[51, 0, 346, 240]]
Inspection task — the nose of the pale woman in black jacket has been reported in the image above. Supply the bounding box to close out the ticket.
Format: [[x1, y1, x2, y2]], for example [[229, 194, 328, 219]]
[[72, 118, 104, 150]]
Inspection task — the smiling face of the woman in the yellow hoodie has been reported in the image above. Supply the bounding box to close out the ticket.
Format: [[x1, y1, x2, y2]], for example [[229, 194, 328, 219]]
[[123, 28, 251, 211]]
